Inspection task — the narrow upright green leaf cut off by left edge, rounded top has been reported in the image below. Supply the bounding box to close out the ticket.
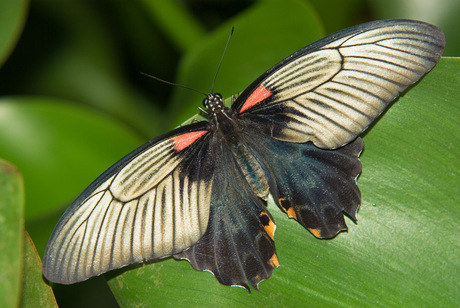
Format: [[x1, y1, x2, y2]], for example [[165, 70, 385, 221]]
[[0, 160, 24, 307]]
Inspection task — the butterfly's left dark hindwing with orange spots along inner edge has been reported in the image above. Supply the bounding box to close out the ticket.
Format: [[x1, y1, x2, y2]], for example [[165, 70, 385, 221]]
[[175, 136, 279, 291]]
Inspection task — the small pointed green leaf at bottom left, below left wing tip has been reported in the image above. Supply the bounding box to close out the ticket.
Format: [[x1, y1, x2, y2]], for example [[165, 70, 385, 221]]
[[21, 231, 57, 308]]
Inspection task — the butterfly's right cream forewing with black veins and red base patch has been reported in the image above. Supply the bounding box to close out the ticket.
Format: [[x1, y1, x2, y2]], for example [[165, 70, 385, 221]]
[[232, 20, 445, 149]]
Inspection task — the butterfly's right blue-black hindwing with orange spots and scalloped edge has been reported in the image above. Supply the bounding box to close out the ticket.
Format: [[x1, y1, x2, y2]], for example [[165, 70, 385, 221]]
[[240, 116, 364, 238]]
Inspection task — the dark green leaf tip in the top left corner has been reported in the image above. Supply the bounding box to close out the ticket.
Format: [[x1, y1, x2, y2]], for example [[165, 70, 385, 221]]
[[0, 0, 29, 67]]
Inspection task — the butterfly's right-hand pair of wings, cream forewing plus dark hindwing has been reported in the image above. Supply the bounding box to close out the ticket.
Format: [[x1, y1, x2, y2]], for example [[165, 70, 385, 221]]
[[232, 20, 445, 238]]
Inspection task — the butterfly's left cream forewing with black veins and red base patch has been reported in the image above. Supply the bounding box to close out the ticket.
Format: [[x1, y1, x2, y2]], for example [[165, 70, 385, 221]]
[[43, 122, 214, 284]]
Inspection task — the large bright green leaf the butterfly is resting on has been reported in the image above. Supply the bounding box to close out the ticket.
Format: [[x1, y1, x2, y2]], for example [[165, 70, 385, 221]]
[[109, 59, 460, 307]]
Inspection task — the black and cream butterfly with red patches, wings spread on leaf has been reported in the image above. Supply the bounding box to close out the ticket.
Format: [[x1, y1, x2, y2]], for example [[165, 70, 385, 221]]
[[43, 20, 445, 291]]
